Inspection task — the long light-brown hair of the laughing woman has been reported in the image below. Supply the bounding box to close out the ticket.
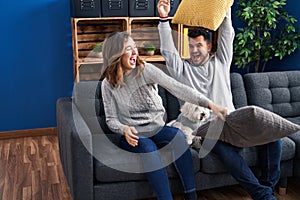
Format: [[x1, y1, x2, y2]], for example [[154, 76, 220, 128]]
[[100, 32, 144, 88]]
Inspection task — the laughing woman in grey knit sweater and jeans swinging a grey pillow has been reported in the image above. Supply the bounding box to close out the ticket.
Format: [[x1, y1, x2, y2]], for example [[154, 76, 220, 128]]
[[101, 32, 227, 200]]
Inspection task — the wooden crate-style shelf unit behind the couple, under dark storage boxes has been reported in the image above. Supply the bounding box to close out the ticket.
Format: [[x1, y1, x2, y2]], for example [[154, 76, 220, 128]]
[[72, 17, 180, 82]]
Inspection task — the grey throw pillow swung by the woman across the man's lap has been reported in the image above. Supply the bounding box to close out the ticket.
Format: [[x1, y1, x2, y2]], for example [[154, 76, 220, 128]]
[[196, 106, 300, 147]]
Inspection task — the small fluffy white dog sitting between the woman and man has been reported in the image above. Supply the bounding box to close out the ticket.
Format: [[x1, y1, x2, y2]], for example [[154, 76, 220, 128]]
[[167, 102, 210, 149]]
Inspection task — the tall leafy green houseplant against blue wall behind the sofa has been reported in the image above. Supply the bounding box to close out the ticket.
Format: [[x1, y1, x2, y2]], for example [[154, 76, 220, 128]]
[[233, 0, 300, 72]]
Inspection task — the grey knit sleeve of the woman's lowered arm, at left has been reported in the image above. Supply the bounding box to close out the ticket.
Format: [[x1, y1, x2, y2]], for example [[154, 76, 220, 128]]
[[101, 80, 126, 134]]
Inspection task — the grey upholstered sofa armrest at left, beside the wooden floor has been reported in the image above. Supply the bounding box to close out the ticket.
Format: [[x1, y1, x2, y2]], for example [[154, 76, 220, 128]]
[[56, 98, 94, 200]]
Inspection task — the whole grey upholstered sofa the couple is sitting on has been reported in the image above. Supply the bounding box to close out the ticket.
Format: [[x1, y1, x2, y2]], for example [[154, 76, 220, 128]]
[[57, 71, 300, 200]]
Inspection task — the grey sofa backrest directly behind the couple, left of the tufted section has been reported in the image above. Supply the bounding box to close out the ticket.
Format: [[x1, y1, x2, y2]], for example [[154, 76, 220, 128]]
[[73, 73, 247, 133]]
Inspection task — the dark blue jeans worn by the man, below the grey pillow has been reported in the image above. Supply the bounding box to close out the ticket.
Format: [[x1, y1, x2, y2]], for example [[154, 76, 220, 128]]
[[212, 140, 282, 200]]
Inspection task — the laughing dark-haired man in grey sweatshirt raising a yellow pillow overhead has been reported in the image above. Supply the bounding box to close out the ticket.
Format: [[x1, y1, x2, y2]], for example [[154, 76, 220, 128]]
[[157, 0, 282, 200]]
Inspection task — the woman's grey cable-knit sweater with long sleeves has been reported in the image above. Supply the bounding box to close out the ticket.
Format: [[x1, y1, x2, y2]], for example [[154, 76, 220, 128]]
[[101, 63, 210, 135]]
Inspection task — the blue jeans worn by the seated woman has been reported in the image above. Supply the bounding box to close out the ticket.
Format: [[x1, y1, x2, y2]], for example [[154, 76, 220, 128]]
[[120, 126, 196, 200]]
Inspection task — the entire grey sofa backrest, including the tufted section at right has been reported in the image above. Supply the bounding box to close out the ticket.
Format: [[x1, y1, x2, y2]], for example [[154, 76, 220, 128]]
[[73, 71, 300, 133]]
